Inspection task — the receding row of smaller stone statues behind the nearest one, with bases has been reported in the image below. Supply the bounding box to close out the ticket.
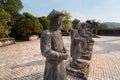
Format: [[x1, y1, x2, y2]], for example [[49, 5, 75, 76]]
[[66, 19, 94, 80]]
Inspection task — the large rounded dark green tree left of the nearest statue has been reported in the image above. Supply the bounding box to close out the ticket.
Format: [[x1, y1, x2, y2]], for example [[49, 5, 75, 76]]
[[12, 13, 42, 36]]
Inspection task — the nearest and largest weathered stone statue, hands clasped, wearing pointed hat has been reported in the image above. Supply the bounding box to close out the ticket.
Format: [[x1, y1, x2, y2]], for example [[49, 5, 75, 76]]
[[41, 10, 68, 80]]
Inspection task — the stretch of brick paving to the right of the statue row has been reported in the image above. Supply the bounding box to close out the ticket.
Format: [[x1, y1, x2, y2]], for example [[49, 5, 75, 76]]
[[88, 36, 120, 80]]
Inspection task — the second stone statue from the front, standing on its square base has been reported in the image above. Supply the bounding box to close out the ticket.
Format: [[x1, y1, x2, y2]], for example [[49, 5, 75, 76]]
[[67, 19, 89, 80]]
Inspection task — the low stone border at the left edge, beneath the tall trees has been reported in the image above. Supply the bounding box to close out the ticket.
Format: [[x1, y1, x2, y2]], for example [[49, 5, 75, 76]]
[[0, 38, 15, 47]]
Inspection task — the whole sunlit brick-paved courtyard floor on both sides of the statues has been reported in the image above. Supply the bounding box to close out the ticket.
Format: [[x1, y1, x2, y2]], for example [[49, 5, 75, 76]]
[[0, 36, 120, 80]]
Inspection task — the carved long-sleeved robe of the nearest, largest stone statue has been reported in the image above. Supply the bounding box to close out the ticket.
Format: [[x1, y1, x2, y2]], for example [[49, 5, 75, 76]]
[[41, 30, 66, 80]]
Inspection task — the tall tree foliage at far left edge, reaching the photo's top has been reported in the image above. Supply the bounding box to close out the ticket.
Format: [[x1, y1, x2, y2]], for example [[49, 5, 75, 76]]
[[0, 0, 23, 37]]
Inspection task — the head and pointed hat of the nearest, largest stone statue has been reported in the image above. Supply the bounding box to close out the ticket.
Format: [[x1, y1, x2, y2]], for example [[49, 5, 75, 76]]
[[47, 9, 64, 30]]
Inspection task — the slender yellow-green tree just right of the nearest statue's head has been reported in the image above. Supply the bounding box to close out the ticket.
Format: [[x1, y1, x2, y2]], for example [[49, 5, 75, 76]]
[[62, 10, 71, 32]]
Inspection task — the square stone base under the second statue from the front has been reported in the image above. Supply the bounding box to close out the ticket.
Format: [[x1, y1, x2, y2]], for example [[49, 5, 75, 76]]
[[66, 61, 90, 80]]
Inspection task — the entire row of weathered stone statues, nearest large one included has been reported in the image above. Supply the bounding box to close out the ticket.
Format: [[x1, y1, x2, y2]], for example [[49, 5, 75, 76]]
[[40, 10, 97, 80]]
